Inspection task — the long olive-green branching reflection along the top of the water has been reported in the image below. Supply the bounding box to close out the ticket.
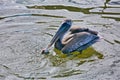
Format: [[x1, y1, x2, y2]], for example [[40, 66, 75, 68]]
[[27, 0, 120, 21]]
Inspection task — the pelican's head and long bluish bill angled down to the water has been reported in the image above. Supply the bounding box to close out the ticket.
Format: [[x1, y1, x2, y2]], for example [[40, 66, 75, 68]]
[[48, 19, 72, 48]]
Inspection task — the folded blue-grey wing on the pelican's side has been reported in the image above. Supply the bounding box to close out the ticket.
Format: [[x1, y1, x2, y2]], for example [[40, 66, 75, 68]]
[[62, 32, 99, 53]]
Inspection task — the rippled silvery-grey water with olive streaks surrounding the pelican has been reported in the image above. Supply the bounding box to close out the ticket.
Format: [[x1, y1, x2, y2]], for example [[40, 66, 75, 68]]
[[0, 0, 120, 80]]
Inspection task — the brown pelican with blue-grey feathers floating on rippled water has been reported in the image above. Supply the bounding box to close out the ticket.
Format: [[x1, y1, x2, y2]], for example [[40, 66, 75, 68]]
[[42, 19, 100, 54]]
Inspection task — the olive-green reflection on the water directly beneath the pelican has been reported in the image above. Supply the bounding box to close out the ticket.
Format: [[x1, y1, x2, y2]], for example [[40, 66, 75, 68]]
[[49, 47, 104, 66]]
